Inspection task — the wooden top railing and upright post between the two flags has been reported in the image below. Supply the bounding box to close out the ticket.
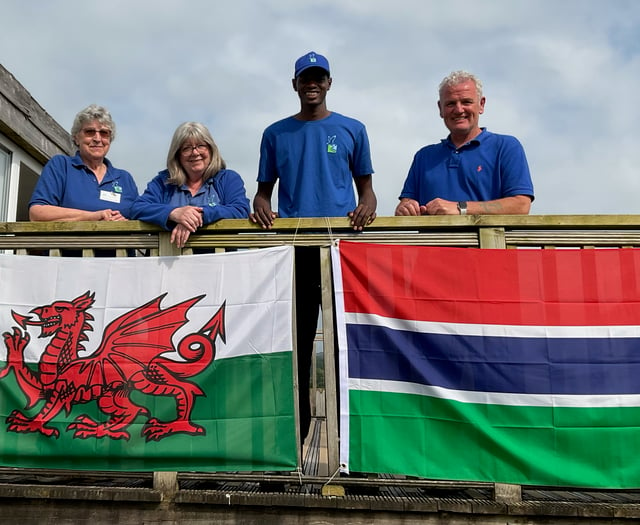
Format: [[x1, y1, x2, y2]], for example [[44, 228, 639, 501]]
[[0, 215, 640, 500]]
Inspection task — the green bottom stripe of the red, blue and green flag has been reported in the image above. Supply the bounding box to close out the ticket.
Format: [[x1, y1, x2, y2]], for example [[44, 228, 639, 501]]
[[349, 390, 640, 489]]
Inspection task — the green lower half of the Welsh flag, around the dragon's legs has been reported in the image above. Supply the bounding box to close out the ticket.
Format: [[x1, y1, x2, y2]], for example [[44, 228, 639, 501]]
[[0, 352, 297, 471]]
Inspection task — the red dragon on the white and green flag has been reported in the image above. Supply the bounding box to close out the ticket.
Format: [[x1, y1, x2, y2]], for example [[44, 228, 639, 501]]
[[0, 291, 225, 441]]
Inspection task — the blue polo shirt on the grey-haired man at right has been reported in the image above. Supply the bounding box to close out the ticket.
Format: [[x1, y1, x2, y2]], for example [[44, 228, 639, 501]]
[[400, 128, 534, 204]]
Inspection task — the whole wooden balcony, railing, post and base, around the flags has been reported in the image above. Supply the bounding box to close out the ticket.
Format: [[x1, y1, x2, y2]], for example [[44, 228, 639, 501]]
[[0, 215, 640, 525]]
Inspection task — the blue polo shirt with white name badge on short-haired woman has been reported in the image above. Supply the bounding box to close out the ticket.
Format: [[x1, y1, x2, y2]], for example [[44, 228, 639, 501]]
[[29, 152, 138, 219]]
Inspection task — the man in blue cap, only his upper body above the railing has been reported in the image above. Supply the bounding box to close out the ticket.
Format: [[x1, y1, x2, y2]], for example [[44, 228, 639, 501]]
[[252, 52, 376, 225]]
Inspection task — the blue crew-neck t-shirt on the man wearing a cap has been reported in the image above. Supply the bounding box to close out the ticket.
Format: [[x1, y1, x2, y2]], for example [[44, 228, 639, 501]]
[[258, 113, 373, 217]]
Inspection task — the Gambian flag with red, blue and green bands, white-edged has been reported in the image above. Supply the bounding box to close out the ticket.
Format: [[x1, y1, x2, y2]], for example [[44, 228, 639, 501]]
[[333, 242, 640, 488]]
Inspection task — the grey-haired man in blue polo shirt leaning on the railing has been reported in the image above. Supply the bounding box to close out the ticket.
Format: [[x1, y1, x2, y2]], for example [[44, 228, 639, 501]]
[[395, 71, 534, 215]]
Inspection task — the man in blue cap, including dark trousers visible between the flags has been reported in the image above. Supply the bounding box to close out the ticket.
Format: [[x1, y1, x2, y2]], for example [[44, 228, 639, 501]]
[[251, 52, 377, 442]]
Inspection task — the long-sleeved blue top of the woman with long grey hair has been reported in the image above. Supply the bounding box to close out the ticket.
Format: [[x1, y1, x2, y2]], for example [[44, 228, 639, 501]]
[[131, 169, 250, 230]]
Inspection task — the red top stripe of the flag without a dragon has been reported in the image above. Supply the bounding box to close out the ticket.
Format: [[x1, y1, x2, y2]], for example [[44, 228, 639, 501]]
[[340, 241, 640, 326]]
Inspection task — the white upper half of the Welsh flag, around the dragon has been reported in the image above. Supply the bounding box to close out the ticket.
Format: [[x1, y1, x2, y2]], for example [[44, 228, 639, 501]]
[[0, 246, 293, 362]]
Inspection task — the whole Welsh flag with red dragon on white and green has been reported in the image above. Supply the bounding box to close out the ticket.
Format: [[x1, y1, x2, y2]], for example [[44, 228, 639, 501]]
[[0, 247, 297, 471]]
